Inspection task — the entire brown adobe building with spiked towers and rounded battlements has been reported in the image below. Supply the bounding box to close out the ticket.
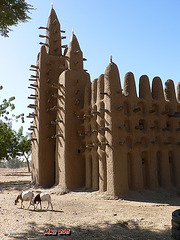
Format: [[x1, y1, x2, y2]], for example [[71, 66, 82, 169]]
[[28, 7, 180, 196]]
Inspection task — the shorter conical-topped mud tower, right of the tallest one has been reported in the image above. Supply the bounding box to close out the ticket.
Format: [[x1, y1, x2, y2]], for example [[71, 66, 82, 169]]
[[56, 32, 90, 189]]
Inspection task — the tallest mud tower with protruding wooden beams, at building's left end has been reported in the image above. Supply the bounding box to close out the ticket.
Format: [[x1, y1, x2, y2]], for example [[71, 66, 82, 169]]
[[28, 7, 67, 187]]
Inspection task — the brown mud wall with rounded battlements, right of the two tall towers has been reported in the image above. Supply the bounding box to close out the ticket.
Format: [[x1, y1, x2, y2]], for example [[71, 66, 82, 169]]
[[84, 61, 180, 195]]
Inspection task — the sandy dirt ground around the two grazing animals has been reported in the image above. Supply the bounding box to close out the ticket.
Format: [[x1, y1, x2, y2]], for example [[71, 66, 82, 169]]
[[0, 168, 180, 240]]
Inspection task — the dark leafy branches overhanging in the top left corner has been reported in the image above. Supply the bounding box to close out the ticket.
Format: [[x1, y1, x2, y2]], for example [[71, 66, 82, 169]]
[[0, 0, 34, 37]]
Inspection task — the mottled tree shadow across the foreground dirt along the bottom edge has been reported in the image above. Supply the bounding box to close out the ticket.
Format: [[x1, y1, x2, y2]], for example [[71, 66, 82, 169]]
[[2, 220, 171, 240]]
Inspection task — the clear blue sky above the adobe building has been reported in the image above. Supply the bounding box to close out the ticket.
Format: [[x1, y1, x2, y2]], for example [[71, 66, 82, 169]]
[[0, 0, 180, 132]]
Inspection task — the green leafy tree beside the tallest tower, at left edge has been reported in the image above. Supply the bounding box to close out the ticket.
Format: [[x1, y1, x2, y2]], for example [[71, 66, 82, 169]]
[[0, 86, 31, 172]]
